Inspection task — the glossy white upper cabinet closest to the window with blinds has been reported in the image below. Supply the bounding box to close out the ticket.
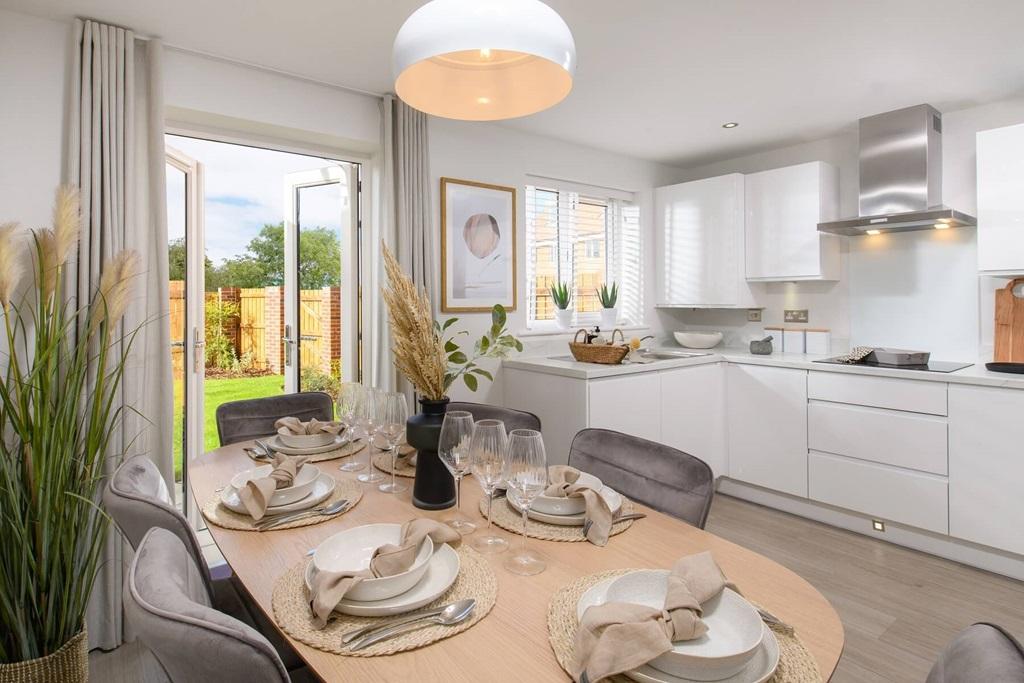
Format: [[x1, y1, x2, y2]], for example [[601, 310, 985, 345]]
[[654, 173, 756, 308]]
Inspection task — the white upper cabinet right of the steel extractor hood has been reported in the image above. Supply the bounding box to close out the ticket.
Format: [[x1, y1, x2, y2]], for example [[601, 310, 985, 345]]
[[977, 124, 1024, 274]]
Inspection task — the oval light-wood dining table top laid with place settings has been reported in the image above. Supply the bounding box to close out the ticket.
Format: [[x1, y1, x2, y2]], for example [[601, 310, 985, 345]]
[[188, 442, 844, 683]]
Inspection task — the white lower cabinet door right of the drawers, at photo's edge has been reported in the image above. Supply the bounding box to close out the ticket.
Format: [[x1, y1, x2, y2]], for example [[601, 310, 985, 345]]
[[949, 385, 1024, 554]]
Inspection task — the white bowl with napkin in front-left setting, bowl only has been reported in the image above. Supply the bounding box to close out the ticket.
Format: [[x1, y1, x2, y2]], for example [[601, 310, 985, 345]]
[[313, 524, 434, 602]]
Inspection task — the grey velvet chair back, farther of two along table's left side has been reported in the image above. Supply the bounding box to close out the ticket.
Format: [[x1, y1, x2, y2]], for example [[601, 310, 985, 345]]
[[103, 456, 213, 593]]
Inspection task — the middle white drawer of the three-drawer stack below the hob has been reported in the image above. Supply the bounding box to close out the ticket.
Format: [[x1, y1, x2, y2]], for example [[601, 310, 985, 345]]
[[807, 402, 948, 475]]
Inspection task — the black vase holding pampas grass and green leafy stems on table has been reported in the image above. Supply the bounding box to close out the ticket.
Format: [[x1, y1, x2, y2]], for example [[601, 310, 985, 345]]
[[383, 247, 522, 510]]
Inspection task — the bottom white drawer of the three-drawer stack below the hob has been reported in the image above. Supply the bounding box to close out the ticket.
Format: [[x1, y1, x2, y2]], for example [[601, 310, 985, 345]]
[[807, 452, 949, 533]]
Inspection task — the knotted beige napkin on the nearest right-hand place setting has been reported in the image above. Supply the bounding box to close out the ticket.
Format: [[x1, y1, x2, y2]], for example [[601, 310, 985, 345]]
[[570, 552, 736, 683]]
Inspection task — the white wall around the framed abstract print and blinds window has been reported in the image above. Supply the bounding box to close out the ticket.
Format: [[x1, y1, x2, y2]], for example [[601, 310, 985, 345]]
[[430, 119, 680, 404]]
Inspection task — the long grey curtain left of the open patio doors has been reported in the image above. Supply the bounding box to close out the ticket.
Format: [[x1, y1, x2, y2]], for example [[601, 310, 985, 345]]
[[65, 19, 174, 649]]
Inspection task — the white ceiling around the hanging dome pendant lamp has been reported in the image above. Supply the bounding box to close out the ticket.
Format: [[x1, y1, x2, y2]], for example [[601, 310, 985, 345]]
[[0, 0, 1024, 166]]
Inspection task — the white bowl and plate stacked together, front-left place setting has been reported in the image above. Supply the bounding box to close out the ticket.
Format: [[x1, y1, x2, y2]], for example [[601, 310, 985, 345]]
[[305, 524, 460, 616]]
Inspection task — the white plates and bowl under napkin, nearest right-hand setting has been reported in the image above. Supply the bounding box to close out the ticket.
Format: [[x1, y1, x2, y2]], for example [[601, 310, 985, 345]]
[[577, 569, 779, 683]]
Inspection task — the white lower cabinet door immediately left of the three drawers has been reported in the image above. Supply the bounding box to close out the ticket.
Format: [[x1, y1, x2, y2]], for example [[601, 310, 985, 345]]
[[725, 364, 807, 498]]
